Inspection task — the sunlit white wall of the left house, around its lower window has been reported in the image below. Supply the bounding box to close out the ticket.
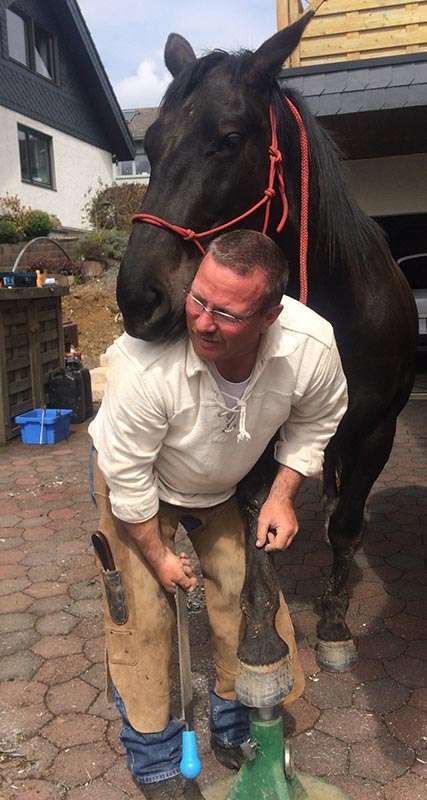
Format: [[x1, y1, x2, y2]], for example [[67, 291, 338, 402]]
[[0, 107, 113, 228]]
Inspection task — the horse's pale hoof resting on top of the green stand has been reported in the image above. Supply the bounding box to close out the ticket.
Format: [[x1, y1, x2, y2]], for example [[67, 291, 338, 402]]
[[236, 658, 294, 708]]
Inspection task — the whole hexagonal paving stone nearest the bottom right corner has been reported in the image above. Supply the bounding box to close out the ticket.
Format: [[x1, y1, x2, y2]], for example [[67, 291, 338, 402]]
[[350, 735, 414, 784]]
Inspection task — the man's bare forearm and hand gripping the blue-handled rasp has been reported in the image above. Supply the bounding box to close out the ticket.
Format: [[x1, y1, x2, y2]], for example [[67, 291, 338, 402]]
[[123, 514, 197, 592]]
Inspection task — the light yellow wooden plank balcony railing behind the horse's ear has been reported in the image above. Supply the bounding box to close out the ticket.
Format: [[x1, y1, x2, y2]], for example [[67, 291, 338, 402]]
[[277, 0, 427, 67]]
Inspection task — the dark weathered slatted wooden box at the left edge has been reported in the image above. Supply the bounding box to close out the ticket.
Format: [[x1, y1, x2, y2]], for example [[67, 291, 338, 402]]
[[0, 287, 68, 444]]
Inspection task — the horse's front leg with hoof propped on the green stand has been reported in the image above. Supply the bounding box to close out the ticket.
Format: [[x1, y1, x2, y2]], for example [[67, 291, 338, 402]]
[[236, 449, 293, 708]]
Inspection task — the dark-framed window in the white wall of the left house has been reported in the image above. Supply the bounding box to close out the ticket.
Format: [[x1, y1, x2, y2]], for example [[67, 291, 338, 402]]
[[18, 125, 53, 189]]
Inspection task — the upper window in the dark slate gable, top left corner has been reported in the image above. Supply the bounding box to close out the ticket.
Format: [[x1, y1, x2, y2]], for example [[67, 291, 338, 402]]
[[6, 8, 56, 81]]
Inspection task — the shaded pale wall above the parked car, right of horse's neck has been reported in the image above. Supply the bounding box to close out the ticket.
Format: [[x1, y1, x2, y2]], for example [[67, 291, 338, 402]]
[[345, 153, 427, 217]]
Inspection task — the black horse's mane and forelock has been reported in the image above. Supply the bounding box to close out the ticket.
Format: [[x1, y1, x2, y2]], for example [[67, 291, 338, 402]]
[[161, 50, 392, 277]]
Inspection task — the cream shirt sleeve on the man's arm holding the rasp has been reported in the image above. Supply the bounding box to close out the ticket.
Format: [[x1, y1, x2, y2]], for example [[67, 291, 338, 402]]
[[89, 372, 168, 523]]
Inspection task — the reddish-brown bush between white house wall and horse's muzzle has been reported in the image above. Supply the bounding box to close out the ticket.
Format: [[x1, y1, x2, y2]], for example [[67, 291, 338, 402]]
[[83, 182, 147, 233]]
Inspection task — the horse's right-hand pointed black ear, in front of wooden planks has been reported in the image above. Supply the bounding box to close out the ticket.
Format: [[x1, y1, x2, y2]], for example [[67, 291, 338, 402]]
[[247, 11, 314, 81]]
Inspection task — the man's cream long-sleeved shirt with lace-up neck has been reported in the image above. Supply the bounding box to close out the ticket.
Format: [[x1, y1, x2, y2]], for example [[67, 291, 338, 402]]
[[89, 297, 347, 523]]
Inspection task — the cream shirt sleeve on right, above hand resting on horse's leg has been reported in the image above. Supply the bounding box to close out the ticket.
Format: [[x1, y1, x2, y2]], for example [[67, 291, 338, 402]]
[[275, 340, 348, 477]]
